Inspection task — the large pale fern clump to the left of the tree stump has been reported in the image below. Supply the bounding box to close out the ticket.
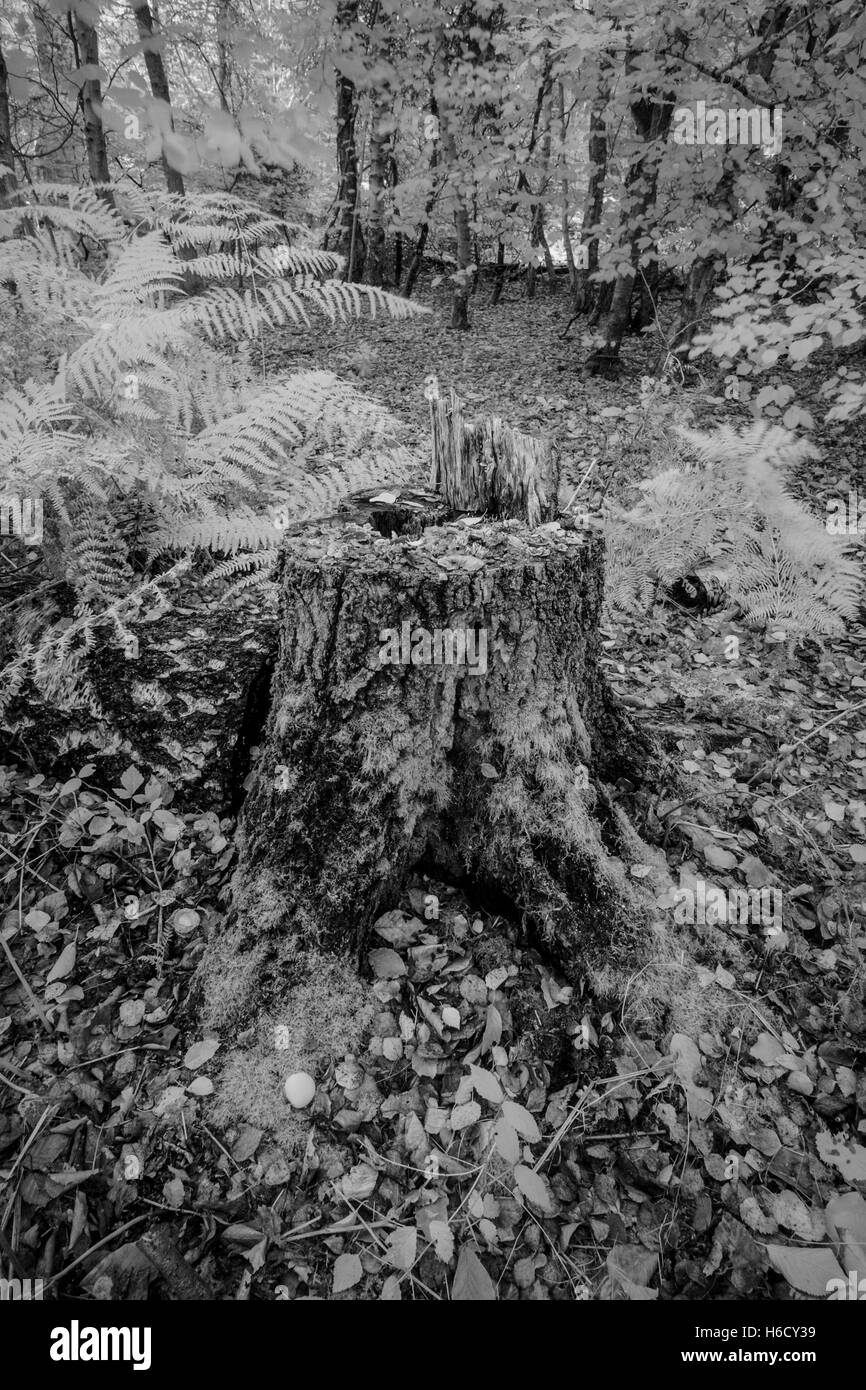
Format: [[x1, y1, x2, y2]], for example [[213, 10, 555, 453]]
[[0, 185, 423, 713]]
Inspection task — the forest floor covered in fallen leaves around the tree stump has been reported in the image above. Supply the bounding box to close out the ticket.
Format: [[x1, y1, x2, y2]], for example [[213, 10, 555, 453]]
[[0, 279, 866, 1300]]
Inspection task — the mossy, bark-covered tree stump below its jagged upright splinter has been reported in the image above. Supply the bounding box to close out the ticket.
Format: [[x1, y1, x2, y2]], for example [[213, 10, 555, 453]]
[[202, 518, 664, 1026]]
